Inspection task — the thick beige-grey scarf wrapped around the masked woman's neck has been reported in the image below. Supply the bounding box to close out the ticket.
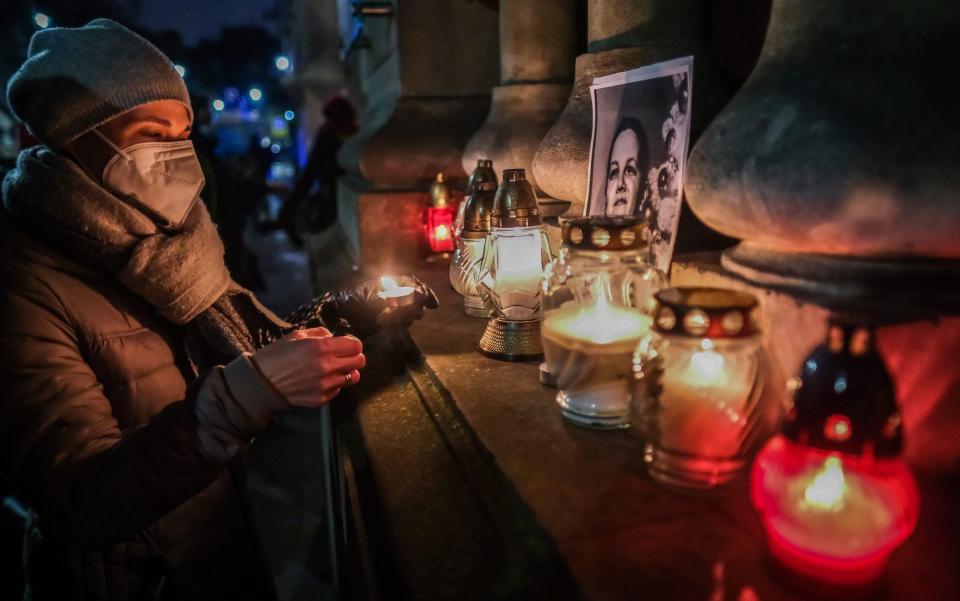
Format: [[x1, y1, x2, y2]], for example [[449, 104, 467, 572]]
[[3, 146, 290, 369]]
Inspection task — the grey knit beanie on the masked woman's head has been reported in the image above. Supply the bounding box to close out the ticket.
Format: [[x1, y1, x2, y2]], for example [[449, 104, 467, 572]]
[[7, 19, 193, 150]]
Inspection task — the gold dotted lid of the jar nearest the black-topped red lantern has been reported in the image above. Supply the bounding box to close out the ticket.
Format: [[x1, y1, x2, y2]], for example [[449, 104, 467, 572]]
[[653, 288, 757, 338]]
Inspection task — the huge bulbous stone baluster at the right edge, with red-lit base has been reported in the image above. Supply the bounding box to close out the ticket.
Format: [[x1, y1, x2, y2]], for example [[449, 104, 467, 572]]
[[674, 0, 960, 471]]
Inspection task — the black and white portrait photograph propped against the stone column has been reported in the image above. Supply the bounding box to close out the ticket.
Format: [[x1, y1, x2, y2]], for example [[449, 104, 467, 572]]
[[586, 56, 693, 271]]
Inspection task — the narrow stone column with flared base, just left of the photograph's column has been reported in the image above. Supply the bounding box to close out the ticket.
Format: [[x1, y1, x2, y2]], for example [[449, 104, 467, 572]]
[[463, 0, 576, 204]]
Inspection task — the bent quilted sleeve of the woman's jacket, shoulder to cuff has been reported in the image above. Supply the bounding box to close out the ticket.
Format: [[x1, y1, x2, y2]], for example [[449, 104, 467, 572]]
[[0, 276, 287, 549]]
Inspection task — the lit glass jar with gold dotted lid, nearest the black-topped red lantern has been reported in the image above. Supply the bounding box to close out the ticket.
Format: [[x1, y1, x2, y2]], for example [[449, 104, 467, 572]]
[[633, 288, 770, 490]]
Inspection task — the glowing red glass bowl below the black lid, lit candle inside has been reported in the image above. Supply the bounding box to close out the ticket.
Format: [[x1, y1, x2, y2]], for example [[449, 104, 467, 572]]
[[752, 437, 917, 584]]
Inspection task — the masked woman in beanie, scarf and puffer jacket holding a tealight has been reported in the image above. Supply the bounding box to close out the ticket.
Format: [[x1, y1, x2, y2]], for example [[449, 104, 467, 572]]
[[0, 19, 436, 601]]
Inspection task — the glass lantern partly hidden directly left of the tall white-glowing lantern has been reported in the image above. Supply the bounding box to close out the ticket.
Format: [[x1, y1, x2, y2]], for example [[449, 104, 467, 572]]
[[450, 181, 497, 317]]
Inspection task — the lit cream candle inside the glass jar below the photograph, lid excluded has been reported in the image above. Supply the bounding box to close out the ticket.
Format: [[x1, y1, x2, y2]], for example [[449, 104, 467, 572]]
[[543, 292, 652, 427]]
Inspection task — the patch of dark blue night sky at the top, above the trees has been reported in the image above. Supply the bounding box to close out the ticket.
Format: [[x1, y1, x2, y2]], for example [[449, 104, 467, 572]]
[[139, 0, 277, 45]]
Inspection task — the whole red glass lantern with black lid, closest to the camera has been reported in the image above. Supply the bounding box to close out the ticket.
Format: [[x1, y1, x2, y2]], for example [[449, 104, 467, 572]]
[[751, 320, 919, 586]]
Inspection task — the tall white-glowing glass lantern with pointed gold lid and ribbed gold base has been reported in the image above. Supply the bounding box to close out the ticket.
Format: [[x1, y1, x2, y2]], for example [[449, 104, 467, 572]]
[[477, 169, 551, 361]]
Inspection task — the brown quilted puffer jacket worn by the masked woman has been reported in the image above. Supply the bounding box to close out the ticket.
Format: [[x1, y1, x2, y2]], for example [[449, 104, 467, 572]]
[[0, 217, 286, 601]]
